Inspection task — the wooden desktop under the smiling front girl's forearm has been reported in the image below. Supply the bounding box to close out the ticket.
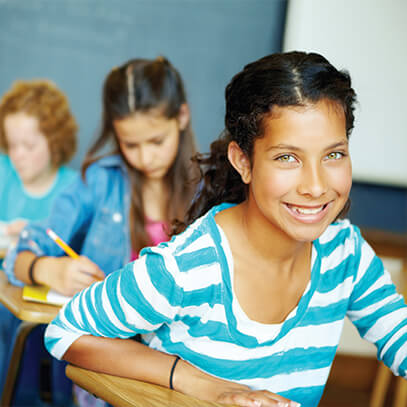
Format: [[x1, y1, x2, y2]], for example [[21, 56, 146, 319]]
[[66, 365, 237, 407]]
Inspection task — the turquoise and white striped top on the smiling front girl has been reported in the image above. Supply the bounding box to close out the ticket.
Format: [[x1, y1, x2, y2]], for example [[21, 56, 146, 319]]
[[45, 204, 407, 407]]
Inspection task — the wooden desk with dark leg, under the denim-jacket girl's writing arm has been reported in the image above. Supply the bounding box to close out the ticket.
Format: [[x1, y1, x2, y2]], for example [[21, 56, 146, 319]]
[[0, 270, 60, 406]]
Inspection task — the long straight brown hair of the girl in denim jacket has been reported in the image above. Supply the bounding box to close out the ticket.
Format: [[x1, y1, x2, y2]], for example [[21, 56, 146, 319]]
[[82, 57, 197, 252]]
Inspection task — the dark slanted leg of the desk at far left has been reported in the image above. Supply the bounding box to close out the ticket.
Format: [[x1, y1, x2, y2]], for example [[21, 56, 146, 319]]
[[0, 321, 39, 406]]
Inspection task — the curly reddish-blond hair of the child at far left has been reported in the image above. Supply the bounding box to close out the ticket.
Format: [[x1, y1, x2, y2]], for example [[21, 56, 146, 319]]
[[0, 79, 78, 167]]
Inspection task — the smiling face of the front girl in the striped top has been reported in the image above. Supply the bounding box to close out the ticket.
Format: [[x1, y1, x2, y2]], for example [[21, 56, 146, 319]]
[[236, 101, 352, 242]]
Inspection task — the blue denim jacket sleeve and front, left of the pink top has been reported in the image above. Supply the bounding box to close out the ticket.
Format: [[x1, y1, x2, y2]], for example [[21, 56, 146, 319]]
[[4, 155, 131, 285]]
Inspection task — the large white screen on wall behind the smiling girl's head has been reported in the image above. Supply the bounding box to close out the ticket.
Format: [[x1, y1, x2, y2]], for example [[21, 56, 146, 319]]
[[283, 0, 407, 187]]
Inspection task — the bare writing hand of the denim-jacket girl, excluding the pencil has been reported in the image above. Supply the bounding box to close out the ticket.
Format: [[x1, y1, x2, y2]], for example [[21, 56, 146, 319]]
[[35, 256, 105, 296]]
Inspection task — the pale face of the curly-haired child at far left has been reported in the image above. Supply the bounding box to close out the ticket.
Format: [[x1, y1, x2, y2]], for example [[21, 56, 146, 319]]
[[4, 112, 53, 184]]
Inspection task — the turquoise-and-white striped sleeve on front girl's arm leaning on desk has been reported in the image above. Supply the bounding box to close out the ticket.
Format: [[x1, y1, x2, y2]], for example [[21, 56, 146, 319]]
[[45, 248, 183, 359]]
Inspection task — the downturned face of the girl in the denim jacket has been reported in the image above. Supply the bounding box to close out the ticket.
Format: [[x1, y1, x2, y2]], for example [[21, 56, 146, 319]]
[[113, 107, 189, 179]]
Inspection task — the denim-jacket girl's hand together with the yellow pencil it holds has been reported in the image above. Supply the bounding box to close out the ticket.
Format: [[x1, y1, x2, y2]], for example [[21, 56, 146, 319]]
[[47, 229, 105, 295]]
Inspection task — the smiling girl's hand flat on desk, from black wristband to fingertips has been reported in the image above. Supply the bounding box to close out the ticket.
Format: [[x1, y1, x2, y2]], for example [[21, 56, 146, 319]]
[[173, 360, 299, 407]]
